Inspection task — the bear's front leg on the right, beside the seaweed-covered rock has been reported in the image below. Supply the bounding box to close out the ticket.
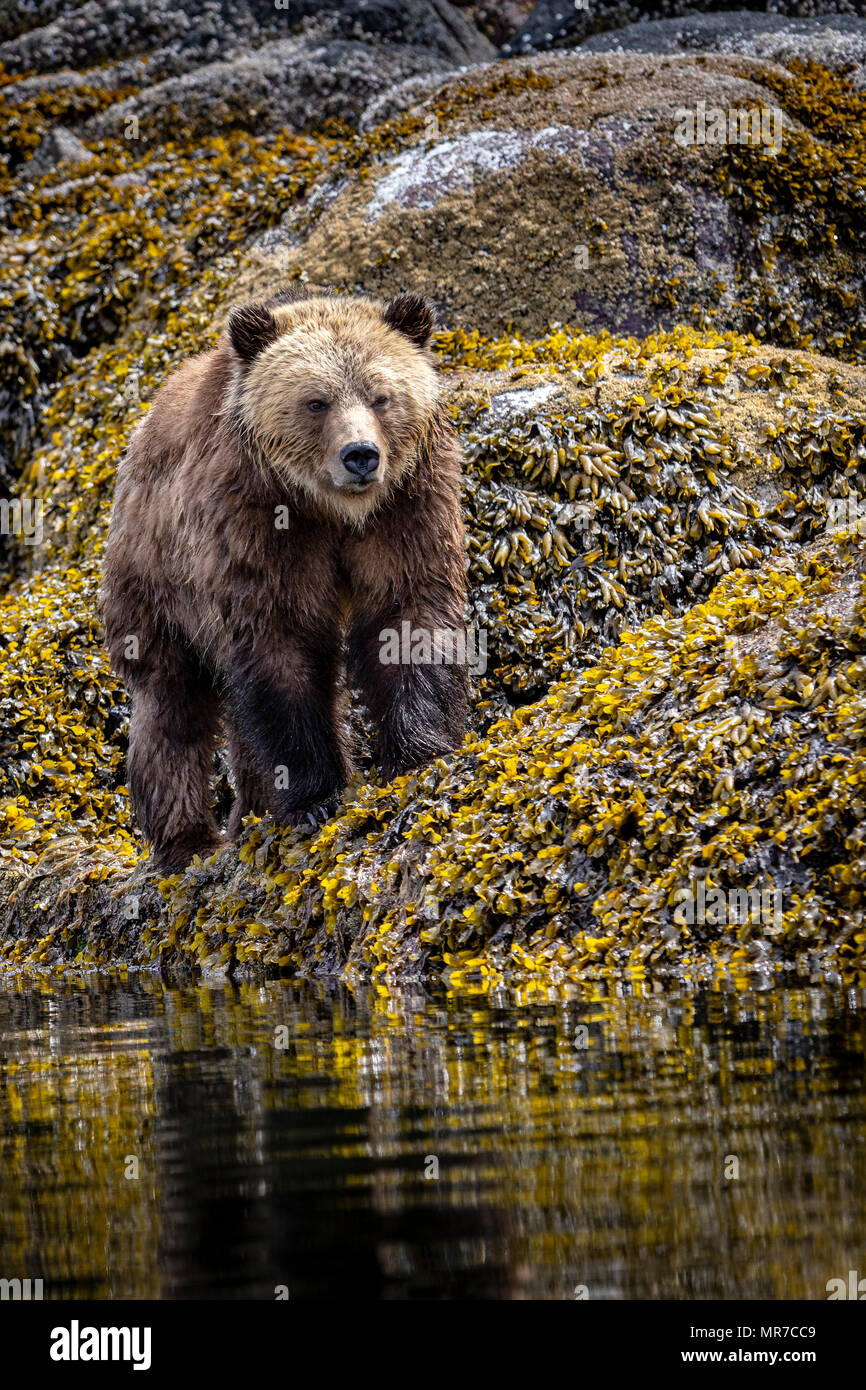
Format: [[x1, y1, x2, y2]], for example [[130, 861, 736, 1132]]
[[348, 610, 468, 777]]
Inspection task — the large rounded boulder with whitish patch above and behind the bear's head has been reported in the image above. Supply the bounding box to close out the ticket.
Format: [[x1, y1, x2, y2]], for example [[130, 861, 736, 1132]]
[[246, 53, 866, 353]]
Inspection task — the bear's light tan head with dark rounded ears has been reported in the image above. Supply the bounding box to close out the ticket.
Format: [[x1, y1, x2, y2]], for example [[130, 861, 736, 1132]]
[[228, 293, 439, 525]]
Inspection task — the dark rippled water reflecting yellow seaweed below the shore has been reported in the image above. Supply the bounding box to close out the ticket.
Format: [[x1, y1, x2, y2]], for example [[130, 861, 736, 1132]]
[[0, 979, 866, 1300]]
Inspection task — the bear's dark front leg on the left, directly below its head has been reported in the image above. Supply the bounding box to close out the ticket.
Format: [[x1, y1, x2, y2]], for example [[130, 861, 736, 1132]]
[[228, 635, 350, 823]]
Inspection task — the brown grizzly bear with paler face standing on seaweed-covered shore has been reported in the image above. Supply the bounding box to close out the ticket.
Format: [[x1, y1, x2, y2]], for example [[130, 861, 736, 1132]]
[[100, 293, 467, 870]]
